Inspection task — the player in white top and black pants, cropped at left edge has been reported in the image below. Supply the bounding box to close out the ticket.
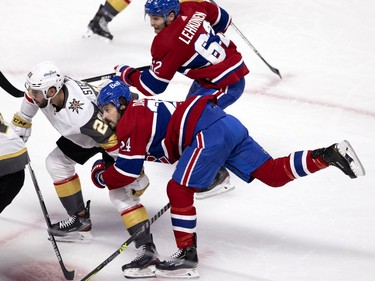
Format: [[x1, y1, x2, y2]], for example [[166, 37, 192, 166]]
[[0, 113, 29, 213]]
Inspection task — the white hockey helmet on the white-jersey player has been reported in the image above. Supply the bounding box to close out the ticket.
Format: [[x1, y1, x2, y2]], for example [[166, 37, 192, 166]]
[[25, 61, 65, 100]]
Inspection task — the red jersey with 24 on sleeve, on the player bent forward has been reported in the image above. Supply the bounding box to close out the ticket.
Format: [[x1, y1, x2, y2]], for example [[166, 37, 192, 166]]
[[103, 96, 224, 189]]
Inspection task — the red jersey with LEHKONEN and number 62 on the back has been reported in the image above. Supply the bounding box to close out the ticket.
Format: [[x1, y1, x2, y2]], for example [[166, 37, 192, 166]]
[[130, 1, 249, 96]]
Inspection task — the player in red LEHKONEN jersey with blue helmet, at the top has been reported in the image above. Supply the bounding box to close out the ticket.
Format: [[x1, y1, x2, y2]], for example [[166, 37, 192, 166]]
[[116, 0, 249, 108]]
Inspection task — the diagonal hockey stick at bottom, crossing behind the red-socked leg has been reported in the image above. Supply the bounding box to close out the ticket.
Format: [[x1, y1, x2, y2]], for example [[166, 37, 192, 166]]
[[81, 202, 171, 281]]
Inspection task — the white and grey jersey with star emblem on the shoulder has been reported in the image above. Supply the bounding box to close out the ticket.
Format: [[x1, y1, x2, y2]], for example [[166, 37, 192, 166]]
[[21, 77, 117, 148]]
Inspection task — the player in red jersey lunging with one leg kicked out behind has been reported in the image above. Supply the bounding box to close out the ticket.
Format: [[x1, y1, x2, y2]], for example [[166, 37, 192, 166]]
[[92, 81, 365, 278]]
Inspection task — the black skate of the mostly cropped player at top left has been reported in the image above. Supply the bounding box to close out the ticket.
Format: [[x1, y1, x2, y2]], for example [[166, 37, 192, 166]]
[[83, 5, 113, 40]]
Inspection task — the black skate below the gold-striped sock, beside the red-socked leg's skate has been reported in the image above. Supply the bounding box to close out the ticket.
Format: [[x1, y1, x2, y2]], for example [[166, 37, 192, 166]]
[[122, 242, 159, 278]]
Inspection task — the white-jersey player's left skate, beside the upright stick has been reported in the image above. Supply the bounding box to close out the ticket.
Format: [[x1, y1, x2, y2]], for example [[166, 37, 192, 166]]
[[50, 200, 92, 242]]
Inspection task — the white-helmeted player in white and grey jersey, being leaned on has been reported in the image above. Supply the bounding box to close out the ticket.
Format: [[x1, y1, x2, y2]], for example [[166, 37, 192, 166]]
[[12, 62, 151, 244]]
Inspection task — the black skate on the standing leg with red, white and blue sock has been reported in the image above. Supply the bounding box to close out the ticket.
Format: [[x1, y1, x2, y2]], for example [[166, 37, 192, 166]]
[[155, 234, 199, 279]]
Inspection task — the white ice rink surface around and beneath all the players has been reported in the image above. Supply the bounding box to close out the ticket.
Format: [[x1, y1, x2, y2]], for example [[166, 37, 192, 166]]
[[0, 0, 375, 281]]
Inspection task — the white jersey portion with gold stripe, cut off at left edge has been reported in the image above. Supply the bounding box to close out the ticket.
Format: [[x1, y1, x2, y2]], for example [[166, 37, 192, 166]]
[[0, 114, 29, 177]]
